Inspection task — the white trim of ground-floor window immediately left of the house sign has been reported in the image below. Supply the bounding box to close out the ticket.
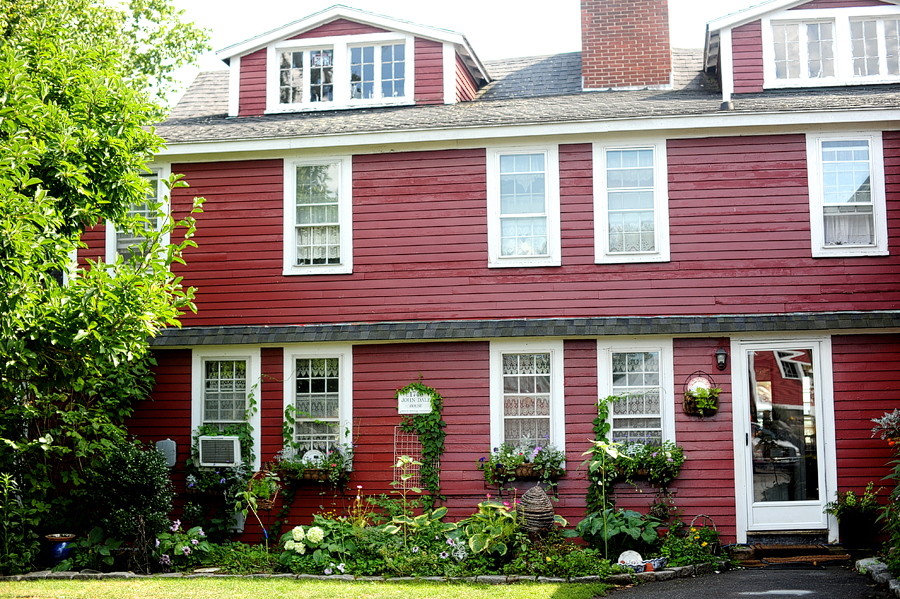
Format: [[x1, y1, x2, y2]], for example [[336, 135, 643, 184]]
[[281, 343, 353, 457]]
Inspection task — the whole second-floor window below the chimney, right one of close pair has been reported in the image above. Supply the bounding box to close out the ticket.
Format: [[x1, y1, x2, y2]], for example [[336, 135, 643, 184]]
[[594, 142, 669, 263]]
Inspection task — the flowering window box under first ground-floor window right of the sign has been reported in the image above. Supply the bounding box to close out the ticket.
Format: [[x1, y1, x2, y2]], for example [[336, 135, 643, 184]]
[[478, 443, 566, 485]]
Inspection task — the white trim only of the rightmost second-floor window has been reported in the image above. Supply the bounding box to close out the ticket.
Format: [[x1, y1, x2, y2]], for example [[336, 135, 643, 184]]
[[806, 131, 890, 258]]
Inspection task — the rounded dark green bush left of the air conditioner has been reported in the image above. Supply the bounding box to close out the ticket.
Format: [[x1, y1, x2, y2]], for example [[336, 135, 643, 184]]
[[88, 443, 175, 540]]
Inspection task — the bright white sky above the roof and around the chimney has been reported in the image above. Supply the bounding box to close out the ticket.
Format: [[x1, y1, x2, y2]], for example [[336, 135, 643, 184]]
[[167, 0, 762, 102]]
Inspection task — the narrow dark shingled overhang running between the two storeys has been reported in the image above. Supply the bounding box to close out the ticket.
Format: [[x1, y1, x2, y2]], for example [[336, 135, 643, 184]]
[[150, 310, 900, 348]]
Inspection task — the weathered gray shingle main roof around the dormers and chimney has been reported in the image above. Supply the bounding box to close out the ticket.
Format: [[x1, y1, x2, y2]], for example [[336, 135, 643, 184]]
[[157, 51, 900, 144]]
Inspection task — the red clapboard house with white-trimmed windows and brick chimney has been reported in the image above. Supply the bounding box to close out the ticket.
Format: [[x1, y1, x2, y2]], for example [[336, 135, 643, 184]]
[[87, 0, 900, 542]]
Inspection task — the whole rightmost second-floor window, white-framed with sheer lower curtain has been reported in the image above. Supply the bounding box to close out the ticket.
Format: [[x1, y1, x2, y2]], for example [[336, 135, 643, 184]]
[[806, 132, 888, 257]]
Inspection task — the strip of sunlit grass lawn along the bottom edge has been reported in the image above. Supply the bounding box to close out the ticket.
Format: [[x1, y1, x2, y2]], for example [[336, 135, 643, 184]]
[[0, 578, 611, 599]]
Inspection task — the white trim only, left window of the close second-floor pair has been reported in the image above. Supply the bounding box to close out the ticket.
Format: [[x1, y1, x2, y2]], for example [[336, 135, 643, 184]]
[[487, 144, 562, 268]]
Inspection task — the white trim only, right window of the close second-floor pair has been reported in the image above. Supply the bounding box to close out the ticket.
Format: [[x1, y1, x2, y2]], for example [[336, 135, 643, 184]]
[[593, 139, 670, 264]]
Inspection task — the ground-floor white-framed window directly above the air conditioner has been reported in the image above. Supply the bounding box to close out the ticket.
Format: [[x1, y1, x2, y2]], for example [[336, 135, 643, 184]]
[[191, 347, 260, 469]]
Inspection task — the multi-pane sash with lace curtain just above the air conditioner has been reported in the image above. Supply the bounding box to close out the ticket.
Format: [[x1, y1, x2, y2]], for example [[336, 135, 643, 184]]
[[202, 359, 248, 424]]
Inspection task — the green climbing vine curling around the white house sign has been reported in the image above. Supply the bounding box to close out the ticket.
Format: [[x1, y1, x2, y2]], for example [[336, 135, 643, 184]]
[[394, 380, 447, 509]]
